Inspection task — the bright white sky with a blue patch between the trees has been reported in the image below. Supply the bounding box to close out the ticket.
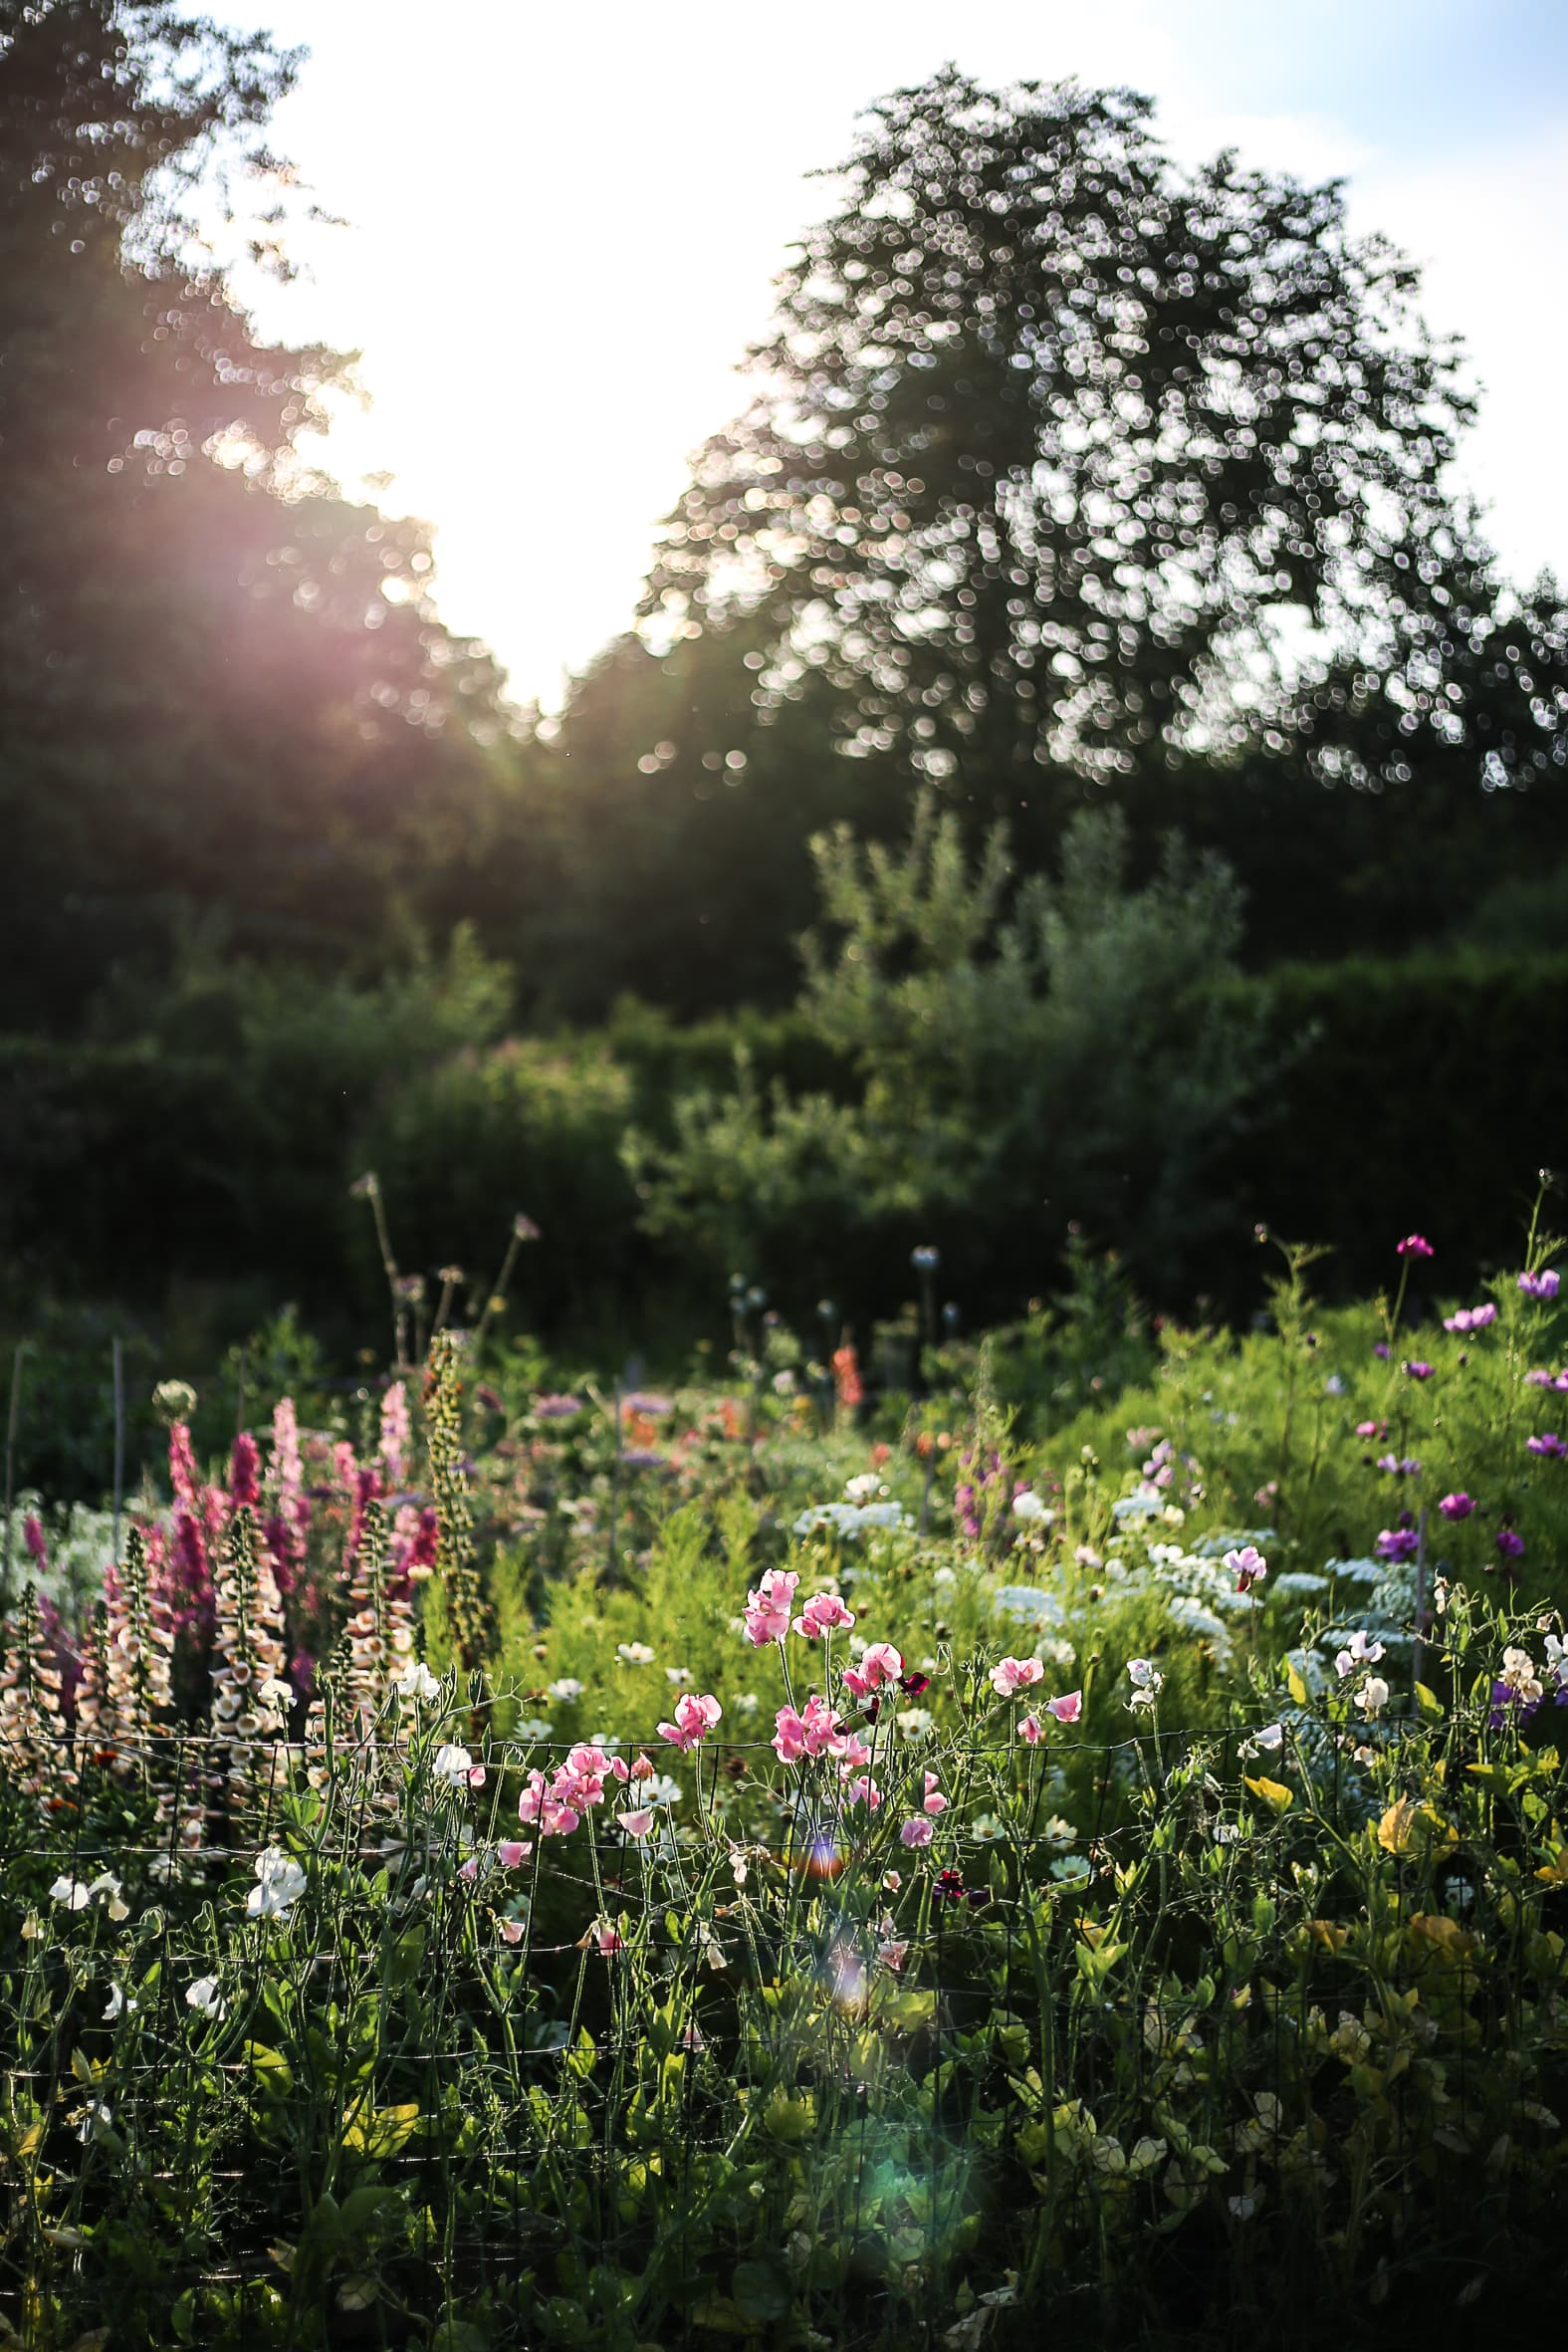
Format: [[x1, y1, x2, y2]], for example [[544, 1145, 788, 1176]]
[[221, 0, 1568, 706]]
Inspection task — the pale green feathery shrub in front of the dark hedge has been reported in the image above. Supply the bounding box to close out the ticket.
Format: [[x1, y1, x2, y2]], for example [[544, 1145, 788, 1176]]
[[632, 798, 1264, 1307]]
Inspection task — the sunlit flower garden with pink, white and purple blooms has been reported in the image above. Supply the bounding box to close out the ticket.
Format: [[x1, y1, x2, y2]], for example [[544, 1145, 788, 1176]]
[[0, 1178, 1568, 2352]]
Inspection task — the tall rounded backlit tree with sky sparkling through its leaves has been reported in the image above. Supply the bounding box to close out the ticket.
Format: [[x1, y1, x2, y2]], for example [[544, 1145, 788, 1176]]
[[646, 71, 1494, 810]]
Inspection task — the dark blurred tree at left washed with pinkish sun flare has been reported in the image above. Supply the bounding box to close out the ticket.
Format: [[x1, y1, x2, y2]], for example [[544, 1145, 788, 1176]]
[[0, 0, 515, 1026]]
